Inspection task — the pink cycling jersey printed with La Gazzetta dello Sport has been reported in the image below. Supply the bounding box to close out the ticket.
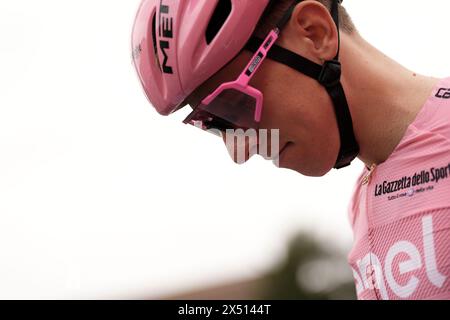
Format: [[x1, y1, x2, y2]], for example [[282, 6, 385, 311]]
[[348, 78, 450, 300]]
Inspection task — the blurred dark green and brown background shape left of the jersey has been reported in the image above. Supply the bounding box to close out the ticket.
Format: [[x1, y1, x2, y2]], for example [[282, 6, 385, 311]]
[[165, 232, 356, 300]]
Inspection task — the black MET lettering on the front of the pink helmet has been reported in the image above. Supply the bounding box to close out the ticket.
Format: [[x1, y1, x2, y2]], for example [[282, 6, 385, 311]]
[[159, 0, 173, 74]]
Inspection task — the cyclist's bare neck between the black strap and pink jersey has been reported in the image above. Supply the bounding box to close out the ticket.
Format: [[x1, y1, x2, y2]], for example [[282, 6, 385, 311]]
[[341, 34, 438, 168]]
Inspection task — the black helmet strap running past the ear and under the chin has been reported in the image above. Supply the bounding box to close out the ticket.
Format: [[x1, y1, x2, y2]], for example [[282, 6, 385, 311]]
[[245, 0, 360, 169]]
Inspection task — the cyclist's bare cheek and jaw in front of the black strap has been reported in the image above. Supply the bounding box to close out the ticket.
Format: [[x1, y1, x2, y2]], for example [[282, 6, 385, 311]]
[[255, 64, 340, 176]]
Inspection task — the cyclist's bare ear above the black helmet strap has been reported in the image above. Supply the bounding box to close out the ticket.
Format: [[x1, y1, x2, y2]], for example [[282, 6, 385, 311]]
[[285, 1, 339, 62]]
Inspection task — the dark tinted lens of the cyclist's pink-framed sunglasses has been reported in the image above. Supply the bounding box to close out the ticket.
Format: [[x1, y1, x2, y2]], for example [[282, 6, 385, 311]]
[[184, 89, 258, 133]]
